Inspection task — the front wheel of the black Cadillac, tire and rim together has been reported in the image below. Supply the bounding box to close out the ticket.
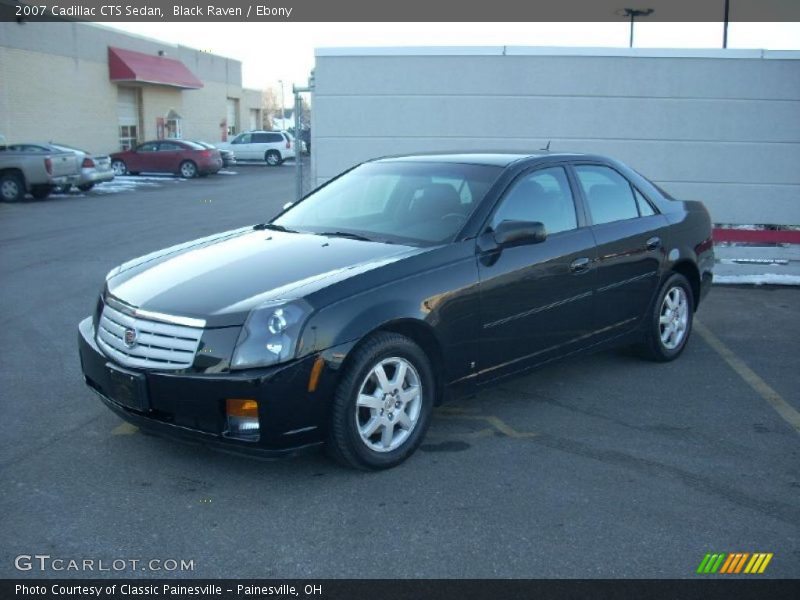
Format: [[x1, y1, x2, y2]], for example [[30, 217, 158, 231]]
[[327, 332, 436, 471]]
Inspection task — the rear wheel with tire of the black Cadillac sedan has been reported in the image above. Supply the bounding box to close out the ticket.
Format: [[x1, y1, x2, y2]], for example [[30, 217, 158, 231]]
[[639, 273, 694, 362]]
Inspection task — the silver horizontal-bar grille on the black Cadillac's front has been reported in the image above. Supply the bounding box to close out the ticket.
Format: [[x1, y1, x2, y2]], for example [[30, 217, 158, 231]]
[[97, 303, 203, 370]]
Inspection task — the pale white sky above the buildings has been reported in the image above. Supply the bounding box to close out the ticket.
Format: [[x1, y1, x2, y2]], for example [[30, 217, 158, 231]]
[[105, 21, 800, 106]]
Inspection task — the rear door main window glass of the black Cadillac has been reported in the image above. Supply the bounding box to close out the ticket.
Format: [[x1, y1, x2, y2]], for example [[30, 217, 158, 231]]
[[575, 165, 639, 225]]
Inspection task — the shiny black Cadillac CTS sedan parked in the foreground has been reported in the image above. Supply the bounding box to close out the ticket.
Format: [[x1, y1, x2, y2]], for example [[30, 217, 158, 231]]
[[79, 153, 713, 469]]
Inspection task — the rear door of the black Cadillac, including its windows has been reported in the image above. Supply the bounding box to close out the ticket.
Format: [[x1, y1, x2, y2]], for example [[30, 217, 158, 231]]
[[574, 163, 667, 338]]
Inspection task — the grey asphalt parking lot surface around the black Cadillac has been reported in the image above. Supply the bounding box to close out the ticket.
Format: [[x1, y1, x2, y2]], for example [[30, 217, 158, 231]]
[[0, 167, 800, 578]]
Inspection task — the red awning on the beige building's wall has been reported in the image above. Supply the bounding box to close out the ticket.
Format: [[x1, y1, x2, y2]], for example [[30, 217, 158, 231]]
[[108, 46, 203, 90]]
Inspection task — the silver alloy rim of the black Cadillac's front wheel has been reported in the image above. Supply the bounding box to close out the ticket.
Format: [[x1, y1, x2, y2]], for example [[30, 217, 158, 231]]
[[355, 357, 422, 452]]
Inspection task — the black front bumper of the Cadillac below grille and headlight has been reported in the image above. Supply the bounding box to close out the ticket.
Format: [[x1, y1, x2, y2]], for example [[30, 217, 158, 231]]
[[78, 317, 347, 458]]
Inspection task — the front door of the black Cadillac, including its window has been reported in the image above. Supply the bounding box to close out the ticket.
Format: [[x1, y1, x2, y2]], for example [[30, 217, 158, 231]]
[[478, 166, 596, 382]]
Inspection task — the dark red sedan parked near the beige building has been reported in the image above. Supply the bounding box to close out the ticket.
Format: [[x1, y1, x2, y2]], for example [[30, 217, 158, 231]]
[[111, 140, 222, 179]]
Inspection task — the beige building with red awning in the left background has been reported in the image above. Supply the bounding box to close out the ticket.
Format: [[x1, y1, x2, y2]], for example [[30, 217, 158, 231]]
[[0, 22, 262, 153]]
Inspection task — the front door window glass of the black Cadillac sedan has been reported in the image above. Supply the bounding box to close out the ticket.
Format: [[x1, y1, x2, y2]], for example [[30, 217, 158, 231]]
[[492, 167, 578, 235]]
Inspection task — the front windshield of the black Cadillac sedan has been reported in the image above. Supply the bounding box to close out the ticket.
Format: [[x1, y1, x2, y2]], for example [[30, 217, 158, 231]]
[[273, 161, 502, 244]]
